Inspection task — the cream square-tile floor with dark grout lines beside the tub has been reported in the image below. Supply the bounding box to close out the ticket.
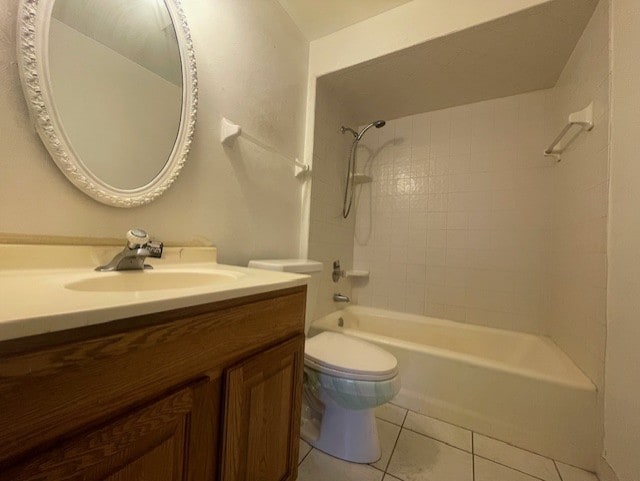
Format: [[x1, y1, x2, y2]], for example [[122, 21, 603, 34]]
[[298, 404, 598, 481]]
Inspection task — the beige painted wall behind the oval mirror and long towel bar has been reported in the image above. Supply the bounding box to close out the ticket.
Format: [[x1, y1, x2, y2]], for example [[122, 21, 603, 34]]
[[0, 0, 308, 264]]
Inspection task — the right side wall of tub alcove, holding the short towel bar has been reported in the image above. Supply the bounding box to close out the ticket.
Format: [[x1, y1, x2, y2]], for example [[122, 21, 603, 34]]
[[548, 0, 610, 452]]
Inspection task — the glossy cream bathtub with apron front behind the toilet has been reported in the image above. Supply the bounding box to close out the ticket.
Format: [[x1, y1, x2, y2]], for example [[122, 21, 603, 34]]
[[310, 306, 599, 470]]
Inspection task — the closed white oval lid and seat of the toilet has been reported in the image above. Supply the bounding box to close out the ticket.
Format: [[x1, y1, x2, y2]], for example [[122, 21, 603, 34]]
[[304, 331, 398, 381]]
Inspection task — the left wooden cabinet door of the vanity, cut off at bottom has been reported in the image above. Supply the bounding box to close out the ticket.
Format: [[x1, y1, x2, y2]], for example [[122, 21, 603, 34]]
[[0, 381, 220, 481]]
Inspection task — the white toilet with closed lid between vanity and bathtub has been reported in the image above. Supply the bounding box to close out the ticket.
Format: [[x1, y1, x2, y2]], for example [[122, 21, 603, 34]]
[[249, 259, 400, 463]]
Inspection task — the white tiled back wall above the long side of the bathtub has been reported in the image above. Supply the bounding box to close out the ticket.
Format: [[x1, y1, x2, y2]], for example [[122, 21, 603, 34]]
[[354, 91, 554, 334]]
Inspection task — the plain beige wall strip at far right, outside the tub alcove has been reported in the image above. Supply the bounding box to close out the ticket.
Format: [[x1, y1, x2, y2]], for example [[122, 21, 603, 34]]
[[604, 0, 640, 481]]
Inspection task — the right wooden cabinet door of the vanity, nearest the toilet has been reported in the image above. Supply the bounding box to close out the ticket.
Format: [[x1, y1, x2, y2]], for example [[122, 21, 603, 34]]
[[221, 335, 304, 481]]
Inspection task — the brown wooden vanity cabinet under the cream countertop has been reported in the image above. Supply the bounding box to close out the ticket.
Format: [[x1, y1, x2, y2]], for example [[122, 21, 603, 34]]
[[0, 287, 305, 481]]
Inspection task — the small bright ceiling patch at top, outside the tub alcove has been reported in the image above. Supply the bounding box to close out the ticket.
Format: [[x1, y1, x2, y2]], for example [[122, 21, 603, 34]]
[[278, 0, 411, 41]]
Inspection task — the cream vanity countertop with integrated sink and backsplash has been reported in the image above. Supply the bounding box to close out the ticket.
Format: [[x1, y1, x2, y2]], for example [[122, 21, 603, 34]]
[[0, 244, 308, 341]]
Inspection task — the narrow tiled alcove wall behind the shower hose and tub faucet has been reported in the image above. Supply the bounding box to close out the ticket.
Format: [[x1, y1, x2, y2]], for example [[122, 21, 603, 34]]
[[309, 82, 356, 319]]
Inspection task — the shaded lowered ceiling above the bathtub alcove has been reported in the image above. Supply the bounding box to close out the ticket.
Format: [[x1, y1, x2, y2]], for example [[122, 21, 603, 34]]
[[319, 0, 598, 124]]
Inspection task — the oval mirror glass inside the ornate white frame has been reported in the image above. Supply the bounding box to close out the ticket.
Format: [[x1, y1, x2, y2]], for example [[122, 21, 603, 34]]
[[49, 0, 182, 189]]
